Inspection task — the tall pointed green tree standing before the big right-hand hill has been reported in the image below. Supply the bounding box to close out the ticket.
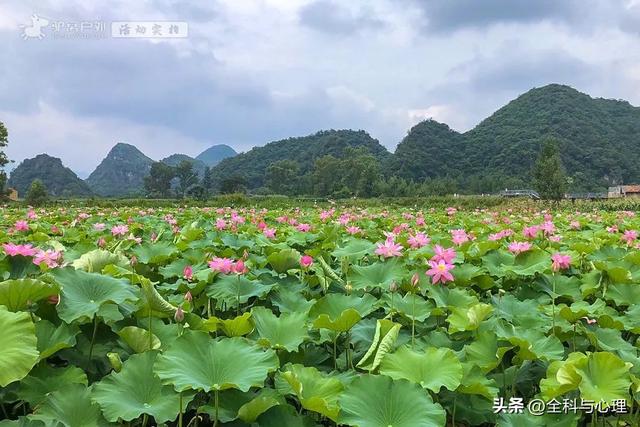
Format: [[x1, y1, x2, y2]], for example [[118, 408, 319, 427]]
[[532, 138, 567, 200]]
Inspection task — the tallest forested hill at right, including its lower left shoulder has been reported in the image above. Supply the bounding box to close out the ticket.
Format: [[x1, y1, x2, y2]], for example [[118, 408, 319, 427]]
[[388, 84, 640, 192]]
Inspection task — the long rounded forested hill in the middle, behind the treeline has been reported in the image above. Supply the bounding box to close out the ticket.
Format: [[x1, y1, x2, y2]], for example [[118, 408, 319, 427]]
[[212, 130, 390, 188]]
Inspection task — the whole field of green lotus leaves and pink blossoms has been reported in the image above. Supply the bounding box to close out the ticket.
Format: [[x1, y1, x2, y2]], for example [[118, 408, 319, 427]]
[[0, 205, 640, 427]]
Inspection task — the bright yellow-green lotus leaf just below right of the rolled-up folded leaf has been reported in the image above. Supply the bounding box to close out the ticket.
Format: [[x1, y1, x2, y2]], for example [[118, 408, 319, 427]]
[[380, 346, 463, 393]]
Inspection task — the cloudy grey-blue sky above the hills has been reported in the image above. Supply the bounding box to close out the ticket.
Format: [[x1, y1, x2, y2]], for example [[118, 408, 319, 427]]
[[0, 0, 640, 178]]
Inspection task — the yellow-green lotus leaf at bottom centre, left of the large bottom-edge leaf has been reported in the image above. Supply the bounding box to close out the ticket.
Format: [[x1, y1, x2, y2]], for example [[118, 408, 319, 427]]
[[275, 365, 344, 421]]
